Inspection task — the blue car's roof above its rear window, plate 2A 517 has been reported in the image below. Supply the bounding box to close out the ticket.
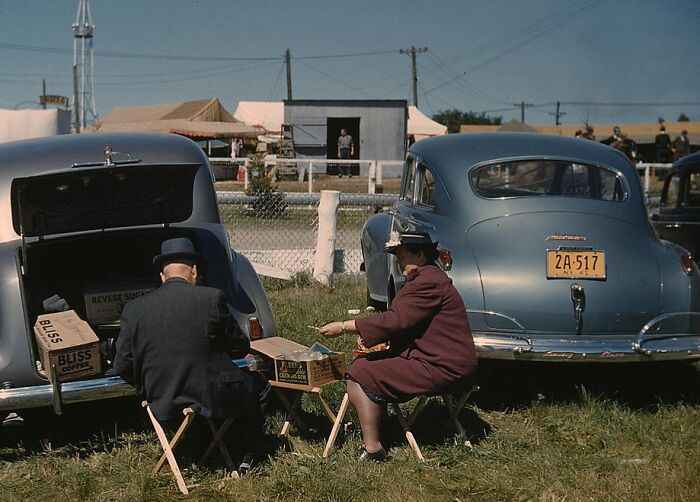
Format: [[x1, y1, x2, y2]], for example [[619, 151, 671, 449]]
[[409, 132, 636, 195]]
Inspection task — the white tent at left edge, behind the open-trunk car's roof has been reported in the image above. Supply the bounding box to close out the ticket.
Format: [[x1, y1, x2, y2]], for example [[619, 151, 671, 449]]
[[0, 108, 70, 143]]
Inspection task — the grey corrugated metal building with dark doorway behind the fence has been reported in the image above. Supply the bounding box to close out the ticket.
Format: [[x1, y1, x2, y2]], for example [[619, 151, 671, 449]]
[[284, 99, 408, 164]]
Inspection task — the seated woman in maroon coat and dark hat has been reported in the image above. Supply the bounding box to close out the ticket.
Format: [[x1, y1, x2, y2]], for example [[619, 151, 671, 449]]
[[321, 233, 476, 460]]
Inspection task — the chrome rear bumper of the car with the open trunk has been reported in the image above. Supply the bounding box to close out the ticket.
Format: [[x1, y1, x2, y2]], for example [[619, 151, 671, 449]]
[[0, 376, 136, 414]]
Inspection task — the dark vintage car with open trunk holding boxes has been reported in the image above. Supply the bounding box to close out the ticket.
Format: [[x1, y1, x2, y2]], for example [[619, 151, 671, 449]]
[[0, 133, 276, 418]]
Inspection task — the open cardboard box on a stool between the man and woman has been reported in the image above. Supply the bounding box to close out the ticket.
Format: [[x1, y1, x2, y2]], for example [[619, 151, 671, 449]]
[[250, 336, 345, 387]]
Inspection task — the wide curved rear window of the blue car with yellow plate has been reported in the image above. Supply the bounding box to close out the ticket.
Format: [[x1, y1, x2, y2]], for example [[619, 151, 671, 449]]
[[471, 160, 627, 201]]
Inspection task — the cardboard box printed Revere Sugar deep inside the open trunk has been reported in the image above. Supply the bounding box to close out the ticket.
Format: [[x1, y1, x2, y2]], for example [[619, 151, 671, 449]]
[[83, 282, 155, 324]]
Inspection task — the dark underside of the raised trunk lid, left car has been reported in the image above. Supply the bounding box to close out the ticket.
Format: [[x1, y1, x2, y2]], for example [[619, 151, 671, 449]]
[[11, 164, 201, 238]]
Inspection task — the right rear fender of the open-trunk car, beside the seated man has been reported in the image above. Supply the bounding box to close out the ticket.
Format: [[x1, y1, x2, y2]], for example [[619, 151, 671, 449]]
[[231, 250, 277, 338]]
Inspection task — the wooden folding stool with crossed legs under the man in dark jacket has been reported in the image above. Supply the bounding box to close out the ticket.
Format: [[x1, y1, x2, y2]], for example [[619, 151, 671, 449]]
[[141, 401, 238, 495]]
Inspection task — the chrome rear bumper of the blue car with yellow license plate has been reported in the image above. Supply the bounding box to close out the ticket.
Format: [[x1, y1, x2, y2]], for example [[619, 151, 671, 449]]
[[468, 310, 700, 362]]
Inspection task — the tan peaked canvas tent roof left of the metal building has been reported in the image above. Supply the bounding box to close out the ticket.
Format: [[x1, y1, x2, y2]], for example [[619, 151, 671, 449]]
[[95, 98, 261, 140]]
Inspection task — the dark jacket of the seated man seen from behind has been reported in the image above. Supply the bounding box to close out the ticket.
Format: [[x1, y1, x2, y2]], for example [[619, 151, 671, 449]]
[[114, 277, 255, 420]]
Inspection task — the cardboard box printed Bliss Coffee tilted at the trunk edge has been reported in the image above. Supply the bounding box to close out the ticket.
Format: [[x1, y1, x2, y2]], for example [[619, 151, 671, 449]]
[[34, 310, 101, 382]]
